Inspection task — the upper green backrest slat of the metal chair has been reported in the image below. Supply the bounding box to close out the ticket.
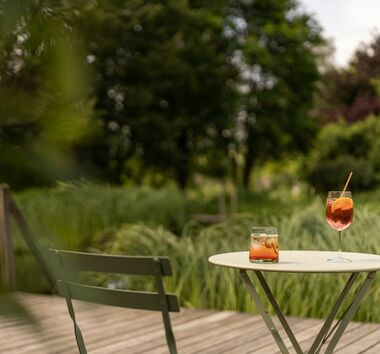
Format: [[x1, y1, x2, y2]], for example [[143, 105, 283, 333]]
[[51, 250, 172, 276]]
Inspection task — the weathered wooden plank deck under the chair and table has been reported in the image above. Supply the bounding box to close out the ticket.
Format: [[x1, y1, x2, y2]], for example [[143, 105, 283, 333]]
[[0, 294, 380, 354]]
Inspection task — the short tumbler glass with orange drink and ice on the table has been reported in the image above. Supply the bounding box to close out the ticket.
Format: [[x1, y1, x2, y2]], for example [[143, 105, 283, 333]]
[[249, 227, 279, 263]]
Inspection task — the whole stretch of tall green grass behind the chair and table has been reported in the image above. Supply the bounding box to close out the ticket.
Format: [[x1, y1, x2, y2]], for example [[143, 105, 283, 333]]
[[10, 183, 380, 322]]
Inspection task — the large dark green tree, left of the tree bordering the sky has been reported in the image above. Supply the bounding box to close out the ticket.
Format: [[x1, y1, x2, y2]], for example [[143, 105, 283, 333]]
[[67, 0, 238, 187]]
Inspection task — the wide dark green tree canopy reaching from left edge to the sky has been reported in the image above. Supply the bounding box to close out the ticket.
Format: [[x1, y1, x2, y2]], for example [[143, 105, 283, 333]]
[[0, 0, 323, 187]]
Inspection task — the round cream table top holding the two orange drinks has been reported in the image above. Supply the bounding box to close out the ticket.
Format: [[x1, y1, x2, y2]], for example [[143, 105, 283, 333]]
[[208, 250, 380, 273]]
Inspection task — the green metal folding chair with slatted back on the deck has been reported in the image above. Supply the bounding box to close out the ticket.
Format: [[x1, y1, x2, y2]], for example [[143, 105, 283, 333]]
[[50, 249, 180, 354]]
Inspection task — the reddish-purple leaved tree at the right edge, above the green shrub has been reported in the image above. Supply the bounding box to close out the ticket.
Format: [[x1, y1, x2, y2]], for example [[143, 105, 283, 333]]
[[317, 34, 380, 123]]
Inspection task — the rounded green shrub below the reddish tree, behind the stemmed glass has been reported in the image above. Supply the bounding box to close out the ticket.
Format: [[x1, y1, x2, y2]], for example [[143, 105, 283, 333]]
[[305, 116, 380, 191]]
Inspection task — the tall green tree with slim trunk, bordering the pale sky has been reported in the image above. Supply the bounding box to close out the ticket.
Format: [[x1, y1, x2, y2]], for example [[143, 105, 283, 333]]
[[228, 0, 323, 186]]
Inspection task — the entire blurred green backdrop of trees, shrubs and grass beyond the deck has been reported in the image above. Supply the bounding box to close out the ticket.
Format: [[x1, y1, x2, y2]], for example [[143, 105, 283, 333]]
[[0, 0, 380, 321]]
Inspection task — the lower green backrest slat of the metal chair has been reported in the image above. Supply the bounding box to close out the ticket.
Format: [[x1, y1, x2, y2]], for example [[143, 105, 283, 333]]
[[57, 280, 180, 312]]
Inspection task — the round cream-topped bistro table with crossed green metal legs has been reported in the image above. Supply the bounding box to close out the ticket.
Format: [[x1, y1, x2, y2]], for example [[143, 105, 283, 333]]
[[209, 251, 380, 354]]
